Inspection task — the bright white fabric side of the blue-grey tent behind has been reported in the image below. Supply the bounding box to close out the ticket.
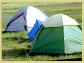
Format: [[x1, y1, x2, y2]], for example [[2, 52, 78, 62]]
[[26, 7, 47, 27]]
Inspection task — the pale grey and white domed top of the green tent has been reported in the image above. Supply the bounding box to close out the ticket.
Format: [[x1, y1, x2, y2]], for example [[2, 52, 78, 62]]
[[43, 14, 78, 27]]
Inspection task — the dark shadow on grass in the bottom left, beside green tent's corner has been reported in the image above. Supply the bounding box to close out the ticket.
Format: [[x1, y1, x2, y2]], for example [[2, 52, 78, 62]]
[[2, 49, 30, 59]]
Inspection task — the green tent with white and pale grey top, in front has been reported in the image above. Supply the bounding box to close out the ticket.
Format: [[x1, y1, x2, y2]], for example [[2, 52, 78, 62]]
[[30, 14, 82, 54]]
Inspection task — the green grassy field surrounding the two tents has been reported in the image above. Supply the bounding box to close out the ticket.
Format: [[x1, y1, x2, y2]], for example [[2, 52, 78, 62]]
[[2, 2, 82, 61]]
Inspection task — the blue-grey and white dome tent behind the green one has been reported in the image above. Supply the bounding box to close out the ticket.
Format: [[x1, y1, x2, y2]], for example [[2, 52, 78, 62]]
[[5, 6, 48, 32]]
